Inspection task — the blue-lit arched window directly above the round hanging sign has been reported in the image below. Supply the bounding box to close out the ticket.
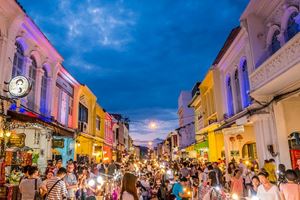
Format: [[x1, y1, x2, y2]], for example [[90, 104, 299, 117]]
[[12, 42, 24, 77]]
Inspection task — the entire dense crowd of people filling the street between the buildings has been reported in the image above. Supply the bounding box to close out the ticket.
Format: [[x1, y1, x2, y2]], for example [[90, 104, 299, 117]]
[[10, 157, 300, 200]]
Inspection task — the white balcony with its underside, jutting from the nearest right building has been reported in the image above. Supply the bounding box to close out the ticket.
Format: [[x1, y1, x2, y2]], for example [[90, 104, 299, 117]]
[[250, 33, 300, 94]]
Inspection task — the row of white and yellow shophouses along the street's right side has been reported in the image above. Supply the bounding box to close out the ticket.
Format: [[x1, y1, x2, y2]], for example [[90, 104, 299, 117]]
[[157, 0, 300, 168]]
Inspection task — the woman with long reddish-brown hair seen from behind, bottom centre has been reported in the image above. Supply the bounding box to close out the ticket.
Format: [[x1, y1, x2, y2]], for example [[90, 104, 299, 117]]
[[120, 173, 139, 200]]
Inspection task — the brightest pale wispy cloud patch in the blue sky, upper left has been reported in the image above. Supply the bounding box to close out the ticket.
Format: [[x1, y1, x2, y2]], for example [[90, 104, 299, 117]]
[[59, 1, 135, 50]]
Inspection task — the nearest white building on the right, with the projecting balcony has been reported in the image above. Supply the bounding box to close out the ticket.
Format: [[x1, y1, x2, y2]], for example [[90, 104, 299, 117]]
[[241, 0, 300, 168]]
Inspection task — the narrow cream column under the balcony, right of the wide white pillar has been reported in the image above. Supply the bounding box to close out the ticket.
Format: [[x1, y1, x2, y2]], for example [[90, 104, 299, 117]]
[[273, 102, 292, 169]]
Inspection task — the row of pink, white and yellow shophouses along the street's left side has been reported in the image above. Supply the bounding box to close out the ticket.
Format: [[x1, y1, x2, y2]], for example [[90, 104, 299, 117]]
[[0, 0, 132, 173]]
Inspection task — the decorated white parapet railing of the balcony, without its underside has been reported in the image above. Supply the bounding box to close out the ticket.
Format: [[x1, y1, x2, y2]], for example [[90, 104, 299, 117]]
[[250, 33, 300, 91]]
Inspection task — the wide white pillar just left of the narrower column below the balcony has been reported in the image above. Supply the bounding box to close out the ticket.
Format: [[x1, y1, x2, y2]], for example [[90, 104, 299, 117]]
[[251, 114, 277, 167]]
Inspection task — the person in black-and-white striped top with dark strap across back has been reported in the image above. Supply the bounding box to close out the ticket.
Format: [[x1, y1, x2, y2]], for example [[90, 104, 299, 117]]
[[46, 167, 68, 200]]
